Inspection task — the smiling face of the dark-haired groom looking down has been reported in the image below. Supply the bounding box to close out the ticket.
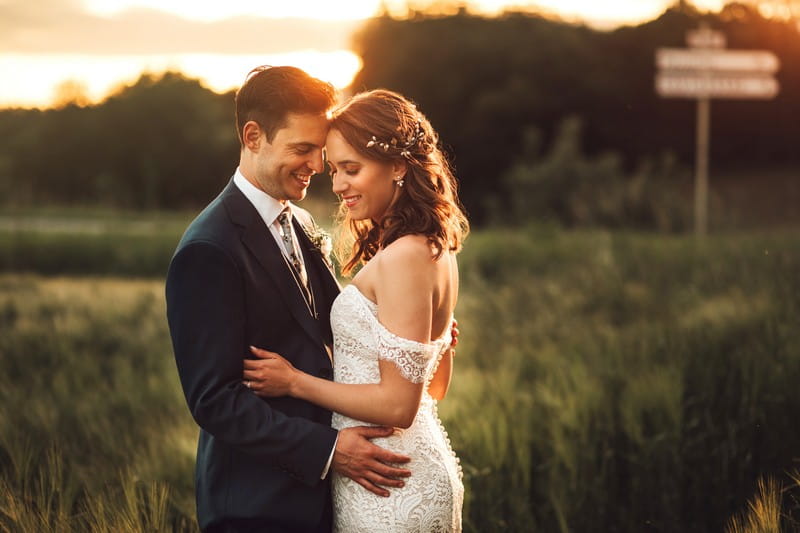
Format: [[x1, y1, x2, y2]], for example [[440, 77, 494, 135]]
[[250, 113, 328, 201]]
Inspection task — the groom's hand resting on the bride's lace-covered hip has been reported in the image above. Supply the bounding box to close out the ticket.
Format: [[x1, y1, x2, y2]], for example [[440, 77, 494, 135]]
[[331, 426, 411, 496]]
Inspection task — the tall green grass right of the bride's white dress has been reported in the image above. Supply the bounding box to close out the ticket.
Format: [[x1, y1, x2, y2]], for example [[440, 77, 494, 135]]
[[441, 228, 800, 532]]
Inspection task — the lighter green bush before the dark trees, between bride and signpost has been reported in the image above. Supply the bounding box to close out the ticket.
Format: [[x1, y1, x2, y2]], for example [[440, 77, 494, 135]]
[[504, 117, 691, 231]]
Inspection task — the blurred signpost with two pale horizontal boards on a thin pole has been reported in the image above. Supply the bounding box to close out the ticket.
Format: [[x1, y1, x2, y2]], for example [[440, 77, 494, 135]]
[[655, 27, 779, 236]]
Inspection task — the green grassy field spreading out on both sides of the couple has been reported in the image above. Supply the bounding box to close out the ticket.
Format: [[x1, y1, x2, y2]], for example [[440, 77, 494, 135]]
[[0, 214, 800, 533]]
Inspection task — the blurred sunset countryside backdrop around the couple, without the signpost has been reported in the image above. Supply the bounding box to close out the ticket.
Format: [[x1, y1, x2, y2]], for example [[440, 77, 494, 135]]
[[0, 0, 800, 533]]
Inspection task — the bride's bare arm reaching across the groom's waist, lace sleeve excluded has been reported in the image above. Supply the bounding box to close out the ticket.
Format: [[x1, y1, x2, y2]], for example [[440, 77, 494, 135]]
[[245, 238, 435, 427]]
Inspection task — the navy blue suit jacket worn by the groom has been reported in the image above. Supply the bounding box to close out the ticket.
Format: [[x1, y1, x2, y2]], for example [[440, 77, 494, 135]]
[[166, 181, 339, 531]]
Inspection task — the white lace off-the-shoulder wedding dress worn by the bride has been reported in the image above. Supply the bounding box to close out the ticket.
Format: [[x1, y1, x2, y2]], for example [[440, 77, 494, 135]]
[[331, 285, 464, 533]]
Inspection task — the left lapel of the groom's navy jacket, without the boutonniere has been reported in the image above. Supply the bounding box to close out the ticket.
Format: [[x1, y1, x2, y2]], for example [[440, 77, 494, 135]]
[[223, 182, 322, 342]]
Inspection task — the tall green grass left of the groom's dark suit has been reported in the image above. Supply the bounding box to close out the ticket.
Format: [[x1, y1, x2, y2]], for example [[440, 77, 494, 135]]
[[0, 276, 197, 532]]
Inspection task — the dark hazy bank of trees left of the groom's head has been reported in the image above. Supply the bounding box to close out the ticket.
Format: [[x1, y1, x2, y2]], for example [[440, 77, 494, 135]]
[[0, 73, 238, 209]]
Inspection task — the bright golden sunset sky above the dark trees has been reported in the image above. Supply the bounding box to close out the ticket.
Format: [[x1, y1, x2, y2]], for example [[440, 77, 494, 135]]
[[0, 0, 724, 107]]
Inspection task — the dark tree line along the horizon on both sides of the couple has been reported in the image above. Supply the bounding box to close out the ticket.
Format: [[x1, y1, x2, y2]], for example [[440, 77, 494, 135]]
[[0, 2, 800, 224]]
